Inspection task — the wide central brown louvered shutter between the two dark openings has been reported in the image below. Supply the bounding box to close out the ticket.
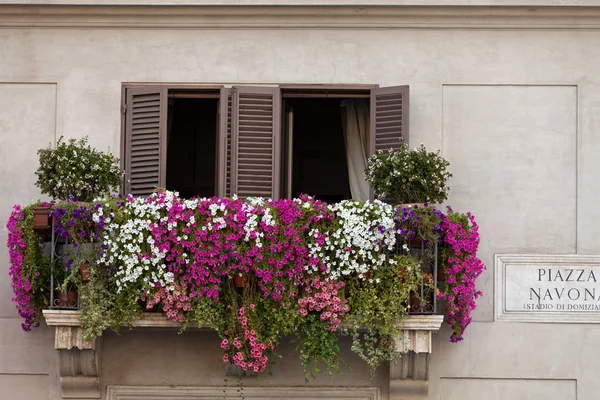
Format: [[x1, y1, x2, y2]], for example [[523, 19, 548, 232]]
[[231, 86, 281, 199]]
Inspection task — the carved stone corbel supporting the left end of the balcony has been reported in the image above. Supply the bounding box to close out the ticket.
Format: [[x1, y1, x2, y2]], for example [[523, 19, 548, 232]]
[[44, 310, 100, 400]]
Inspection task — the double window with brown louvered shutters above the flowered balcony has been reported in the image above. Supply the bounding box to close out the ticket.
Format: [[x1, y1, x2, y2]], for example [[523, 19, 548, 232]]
[[121, 85, 408, 202]]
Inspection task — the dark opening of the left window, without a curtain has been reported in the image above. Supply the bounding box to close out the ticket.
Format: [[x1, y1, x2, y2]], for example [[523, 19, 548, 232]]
[[166, 98, 218, 198]]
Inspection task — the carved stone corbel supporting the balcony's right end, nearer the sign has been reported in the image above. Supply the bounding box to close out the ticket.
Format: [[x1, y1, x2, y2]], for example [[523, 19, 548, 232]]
[[390, 315, 444, 400]]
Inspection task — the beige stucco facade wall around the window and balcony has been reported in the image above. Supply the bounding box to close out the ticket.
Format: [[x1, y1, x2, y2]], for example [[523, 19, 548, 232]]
[[0, 3, 600, 400]]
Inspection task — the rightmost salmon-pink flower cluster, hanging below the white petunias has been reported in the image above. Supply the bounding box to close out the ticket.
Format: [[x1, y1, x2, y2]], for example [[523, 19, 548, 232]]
[[298, 277, 350, 332]]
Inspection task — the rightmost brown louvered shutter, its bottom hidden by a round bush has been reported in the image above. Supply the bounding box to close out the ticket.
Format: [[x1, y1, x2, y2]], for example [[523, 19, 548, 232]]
[[369, 86, 409, 155]]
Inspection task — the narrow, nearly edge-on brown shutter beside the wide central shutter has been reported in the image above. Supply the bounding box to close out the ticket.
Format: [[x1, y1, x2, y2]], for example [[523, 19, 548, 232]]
[[217, 88, 232, 197]]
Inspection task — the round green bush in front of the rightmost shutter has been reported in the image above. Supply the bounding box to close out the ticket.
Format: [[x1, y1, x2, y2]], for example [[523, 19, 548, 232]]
[[365, 142, 452, 204]]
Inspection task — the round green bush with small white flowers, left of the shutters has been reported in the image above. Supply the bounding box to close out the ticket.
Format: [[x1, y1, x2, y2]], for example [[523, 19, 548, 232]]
[[35, 136, 121, 201]]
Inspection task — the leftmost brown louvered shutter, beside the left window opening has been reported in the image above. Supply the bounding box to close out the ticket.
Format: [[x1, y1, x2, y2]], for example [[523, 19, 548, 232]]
[[125, 86, 168, 196]]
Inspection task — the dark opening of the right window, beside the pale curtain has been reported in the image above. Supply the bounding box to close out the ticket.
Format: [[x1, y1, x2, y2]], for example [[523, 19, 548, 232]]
[[284, 98, 352, 203]]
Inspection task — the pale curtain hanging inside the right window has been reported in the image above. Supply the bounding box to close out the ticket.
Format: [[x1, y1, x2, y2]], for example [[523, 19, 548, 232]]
[[342, 99, 370, 201]]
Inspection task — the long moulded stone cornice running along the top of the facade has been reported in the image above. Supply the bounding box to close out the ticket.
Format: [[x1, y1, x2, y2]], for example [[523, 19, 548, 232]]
[[0, 1, 600, 30]]
